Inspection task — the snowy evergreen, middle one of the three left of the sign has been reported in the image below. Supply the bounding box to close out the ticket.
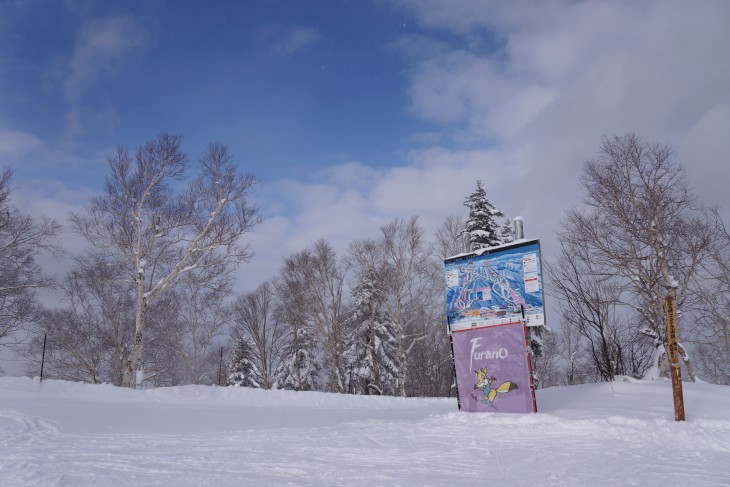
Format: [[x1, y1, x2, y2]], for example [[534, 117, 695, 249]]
[[276, 324, 322, 391]]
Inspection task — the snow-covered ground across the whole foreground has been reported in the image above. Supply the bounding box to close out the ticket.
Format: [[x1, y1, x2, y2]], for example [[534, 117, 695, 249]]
[[0, 377, 730, 487]]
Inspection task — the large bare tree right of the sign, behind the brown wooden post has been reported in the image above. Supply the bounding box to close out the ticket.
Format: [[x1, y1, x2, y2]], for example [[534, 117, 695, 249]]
[[561, 134, 712, 379]]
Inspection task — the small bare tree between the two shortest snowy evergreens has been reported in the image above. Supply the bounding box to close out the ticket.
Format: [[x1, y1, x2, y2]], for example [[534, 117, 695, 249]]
[[233, 281, 286, 389]]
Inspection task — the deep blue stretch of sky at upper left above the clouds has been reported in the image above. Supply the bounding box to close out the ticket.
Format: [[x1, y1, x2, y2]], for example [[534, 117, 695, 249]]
[[0, 1, 430, 185]]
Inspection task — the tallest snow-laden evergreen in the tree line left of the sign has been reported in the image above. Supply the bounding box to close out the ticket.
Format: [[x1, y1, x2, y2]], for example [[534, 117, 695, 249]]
[[343, 268, 398, 394]]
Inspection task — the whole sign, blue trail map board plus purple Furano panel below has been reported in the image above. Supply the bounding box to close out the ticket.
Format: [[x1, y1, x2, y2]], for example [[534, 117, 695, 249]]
[[445, 240, 545, 412]]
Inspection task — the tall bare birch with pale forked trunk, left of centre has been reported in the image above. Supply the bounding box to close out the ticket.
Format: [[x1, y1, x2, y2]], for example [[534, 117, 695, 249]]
[[71, 134, 260, 387]]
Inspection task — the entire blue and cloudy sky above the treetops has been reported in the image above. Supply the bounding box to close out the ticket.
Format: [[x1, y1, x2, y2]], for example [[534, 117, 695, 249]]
[[0, 0, 730, 289]]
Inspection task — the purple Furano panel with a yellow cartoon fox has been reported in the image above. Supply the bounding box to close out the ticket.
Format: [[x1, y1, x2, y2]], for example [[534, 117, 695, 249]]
[[451, 322, 536, 413]]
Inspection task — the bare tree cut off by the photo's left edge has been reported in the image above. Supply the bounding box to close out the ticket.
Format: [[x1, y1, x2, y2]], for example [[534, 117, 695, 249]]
[[0, 169, 60, 346]]
